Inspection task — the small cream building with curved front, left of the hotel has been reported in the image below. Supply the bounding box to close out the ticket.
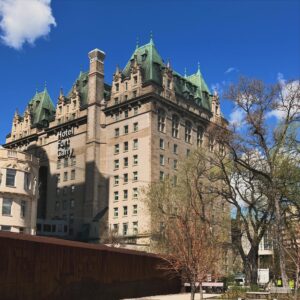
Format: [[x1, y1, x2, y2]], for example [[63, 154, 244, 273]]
[[0, 146, 39, 234]]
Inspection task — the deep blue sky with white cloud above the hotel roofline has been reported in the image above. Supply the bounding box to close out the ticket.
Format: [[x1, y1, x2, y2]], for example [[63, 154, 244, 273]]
[[0, 0, 300, 144]]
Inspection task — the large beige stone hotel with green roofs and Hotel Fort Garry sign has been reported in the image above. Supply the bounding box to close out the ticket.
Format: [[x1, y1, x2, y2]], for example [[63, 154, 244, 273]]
[[5, 39, 226, 249]]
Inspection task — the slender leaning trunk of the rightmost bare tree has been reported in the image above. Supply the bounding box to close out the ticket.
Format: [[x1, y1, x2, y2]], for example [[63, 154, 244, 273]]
[[275, 198, 289, 288]]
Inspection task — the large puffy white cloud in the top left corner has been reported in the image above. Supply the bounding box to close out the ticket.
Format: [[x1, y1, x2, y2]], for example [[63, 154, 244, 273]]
[[0, 0, 56, 49]]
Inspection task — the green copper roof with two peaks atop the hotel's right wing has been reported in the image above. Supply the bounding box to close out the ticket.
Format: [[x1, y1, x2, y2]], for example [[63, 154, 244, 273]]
[[122, 38, 212, 110]]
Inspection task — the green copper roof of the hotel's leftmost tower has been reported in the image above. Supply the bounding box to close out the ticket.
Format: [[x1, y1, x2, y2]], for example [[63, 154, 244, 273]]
[[28, 88, 55, 126]]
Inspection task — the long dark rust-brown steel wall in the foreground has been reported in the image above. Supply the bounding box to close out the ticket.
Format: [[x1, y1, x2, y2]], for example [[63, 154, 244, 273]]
[[0, 232, 180, 300]]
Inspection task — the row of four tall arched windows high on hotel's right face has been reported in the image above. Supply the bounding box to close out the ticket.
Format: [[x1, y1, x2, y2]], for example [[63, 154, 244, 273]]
[[157, 109, 204, 146]]
